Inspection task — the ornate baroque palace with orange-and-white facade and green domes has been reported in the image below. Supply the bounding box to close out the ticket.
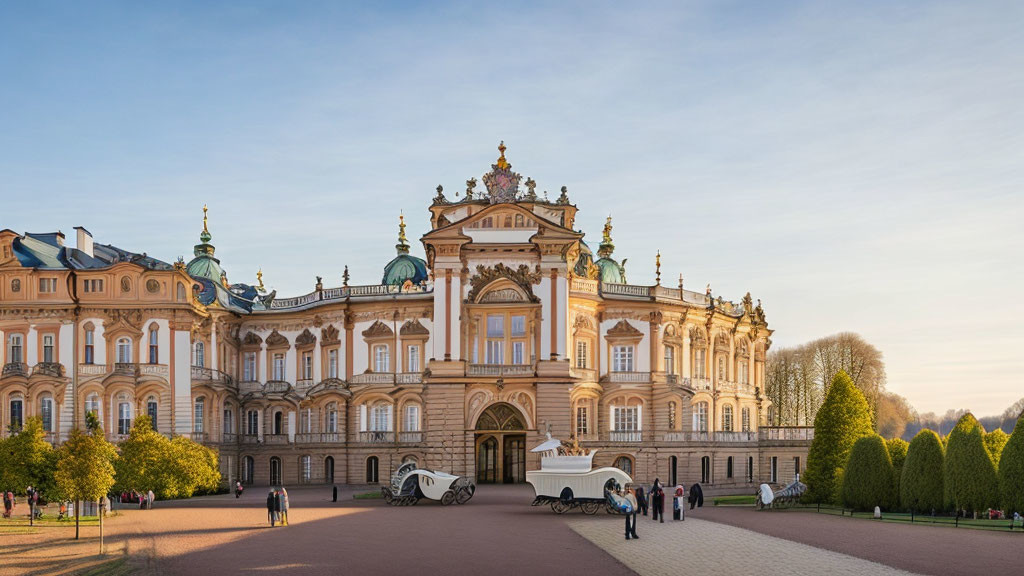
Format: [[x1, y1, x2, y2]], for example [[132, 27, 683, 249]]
[[0, 145, 813, 491]]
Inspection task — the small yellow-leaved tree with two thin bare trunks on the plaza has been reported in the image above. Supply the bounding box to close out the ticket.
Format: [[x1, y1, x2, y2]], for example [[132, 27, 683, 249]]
[[53, 422, 118, 537]]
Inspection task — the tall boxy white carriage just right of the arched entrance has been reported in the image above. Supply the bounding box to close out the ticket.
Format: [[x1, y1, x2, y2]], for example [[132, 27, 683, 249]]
[[526, 435, 633, 515]]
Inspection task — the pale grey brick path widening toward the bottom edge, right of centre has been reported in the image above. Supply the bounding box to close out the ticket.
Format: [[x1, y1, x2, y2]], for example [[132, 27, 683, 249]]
[[569, 516, 909, 576]]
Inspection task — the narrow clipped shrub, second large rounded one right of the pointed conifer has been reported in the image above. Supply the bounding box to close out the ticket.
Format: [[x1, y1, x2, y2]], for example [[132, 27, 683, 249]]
[[899, 428, 945, 512]]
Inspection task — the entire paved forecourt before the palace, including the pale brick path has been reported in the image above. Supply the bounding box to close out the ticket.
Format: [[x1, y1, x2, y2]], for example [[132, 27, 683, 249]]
[[0, 486, 1024, 576]]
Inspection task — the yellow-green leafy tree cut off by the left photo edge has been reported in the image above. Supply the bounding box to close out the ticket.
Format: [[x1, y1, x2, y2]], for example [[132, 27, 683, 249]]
[[0, 416, 56, 497]]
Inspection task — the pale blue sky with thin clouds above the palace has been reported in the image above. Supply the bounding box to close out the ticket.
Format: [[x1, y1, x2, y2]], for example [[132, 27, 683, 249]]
[[0, 2, 1024, 415]]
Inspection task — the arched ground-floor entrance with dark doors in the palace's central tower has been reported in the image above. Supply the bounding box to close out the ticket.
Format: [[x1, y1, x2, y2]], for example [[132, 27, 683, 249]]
[[476, 403, 526, 484]]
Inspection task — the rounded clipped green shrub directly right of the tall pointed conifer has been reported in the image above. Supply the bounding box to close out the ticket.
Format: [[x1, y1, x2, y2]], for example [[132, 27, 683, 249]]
[[842, 435, 896, 510]]
